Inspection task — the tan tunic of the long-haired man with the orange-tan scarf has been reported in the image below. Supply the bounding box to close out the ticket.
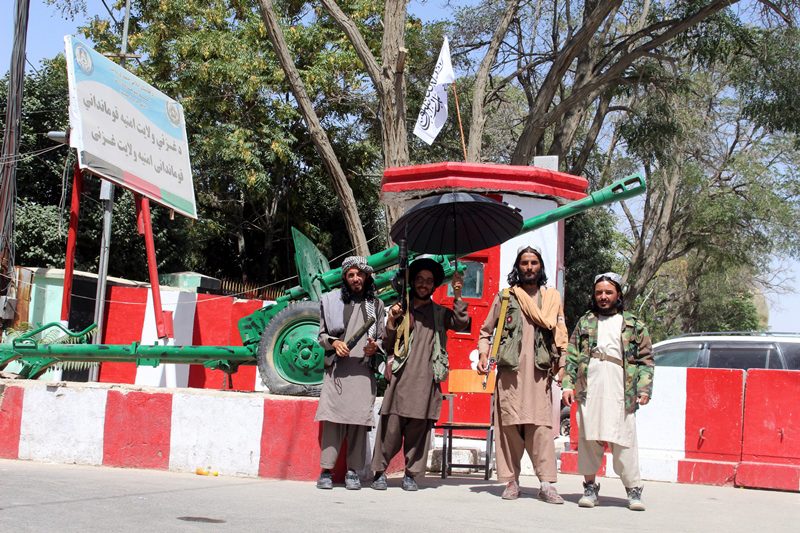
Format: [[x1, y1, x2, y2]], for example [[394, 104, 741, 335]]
[[478, 288, 560, 427]]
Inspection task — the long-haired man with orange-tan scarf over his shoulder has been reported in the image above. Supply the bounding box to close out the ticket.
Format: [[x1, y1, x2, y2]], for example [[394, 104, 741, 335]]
[[478, 246, 567, 504]]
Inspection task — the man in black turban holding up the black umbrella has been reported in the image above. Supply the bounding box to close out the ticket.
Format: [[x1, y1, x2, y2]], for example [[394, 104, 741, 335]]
[[372, 258, 469, 491]]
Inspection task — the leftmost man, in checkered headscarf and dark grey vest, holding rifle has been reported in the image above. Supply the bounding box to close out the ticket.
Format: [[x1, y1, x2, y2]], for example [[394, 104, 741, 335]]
[[314, 256, 385, 490]]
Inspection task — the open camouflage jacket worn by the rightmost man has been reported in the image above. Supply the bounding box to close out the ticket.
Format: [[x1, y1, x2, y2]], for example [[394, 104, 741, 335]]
[[561, 311, 654, 413]]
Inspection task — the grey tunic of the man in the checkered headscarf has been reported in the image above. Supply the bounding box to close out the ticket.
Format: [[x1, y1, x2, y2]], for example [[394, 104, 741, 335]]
[[314, 294, 385, 427]]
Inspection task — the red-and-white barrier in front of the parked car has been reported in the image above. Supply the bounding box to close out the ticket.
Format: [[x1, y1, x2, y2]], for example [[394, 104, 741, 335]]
[[561, 367, 800, 491]]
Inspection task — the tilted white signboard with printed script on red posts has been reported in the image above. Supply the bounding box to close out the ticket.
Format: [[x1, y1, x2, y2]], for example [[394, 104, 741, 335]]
[[64, 35, 197, 218]]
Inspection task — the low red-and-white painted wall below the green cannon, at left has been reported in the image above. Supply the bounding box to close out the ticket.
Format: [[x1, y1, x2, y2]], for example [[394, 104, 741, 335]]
[[0, 380, 319, 480]]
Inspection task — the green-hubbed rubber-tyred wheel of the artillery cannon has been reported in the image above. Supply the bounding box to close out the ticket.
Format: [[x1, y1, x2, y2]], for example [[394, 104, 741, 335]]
[[258, 301, 325, 396]]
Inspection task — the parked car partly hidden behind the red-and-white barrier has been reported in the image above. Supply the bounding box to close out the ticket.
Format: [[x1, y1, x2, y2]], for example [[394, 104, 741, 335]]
[[653, 332, 800, 370]]
